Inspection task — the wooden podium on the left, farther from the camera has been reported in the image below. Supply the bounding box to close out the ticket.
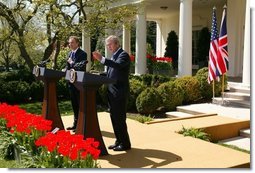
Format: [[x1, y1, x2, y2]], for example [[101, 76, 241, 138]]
[[33, 66, 65, 130]]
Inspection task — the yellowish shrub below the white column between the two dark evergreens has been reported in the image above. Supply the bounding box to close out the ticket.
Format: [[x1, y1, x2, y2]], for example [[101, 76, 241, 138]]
[[174, 76, 201, 104]]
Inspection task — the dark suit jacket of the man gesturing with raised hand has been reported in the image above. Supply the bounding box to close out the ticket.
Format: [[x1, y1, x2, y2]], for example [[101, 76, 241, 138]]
[[104, 48, 130, 101]]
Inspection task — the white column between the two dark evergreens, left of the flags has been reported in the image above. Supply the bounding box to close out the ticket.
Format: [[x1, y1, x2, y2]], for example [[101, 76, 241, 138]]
[[178, 0, 193, 77]]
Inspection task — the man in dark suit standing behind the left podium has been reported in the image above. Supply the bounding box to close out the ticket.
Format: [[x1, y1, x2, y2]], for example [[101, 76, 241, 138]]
[[66, 36, 87, 131]]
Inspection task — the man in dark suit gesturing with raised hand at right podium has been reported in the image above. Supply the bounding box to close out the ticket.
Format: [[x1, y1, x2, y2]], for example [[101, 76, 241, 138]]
[[93, 35, 131, 151]]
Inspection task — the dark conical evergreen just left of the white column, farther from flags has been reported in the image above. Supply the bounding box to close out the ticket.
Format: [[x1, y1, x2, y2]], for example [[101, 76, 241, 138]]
[[164, 31, 179, 69]]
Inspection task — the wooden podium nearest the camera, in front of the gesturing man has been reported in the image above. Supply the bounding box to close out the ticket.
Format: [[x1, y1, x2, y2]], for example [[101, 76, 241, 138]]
[[65, 70, 115, 156]]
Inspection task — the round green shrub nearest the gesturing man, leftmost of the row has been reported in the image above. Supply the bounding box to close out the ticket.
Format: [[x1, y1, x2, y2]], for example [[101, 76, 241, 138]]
[[136, 88, 161, 114]]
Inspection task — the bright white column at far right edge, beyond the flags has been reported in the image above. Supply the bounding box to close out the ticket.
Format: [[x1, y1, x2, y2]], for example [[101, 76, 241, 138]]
[[243, 0, 251, 86]]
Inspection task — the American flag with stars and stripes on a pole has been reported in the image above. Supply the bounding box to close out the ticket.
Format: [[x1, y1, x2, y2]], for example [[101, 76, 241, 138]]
[[208, 7, 220, 83]]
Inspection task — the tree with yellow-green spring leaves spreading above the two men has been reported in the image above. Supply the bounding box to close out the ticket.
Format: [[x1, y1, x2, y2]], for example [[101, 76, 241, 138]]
[[0, 0, 136, 70]]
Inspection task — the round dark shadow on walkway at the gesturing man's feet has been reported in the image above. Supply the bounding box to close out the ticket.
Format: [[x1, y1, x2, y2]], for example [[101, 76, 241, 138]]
[[100, 148, 182, 168]]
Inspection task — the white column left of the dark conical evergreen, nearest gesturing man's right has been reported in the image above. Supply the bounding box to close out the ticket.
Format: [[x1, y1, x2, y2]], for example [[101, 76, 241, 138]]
[[135, 7, 147, 75]]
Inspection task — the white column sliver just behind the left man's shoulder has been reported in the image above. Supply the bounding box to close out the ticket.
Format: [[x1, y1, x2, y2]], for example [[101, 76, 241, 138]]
[[82, 30, 91, 72]]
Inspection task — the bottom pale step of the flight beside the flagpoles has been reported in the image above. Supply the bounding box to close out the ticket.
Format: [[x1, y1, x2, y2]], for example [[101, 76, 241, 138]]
[[213, 97, 251, 108]]
